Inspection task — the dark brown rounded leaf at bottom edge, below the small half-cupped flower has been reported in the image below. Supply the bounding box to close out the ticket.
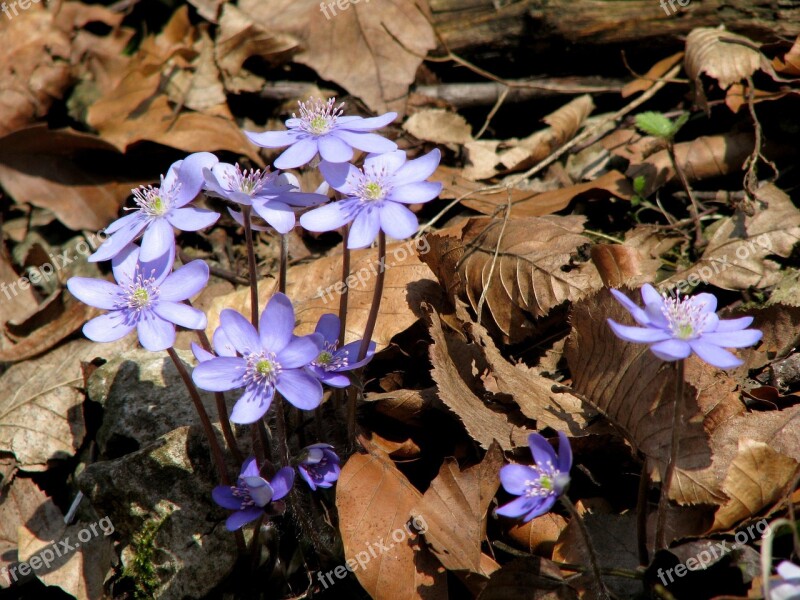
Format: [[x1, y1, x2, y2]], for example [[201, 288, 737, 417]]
[[477, 556, 578, 600]]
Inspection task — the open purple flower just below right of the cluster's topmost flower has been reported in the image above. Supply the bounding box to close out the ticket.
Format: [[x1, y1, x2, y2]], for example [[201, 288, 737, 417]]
[[300, 150, 442, 248]]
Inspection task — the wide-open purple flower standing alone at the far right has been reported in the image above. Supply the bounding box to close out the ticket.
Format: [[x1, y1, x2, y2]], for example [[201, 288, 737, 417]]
[[608, 284, 762, 369]]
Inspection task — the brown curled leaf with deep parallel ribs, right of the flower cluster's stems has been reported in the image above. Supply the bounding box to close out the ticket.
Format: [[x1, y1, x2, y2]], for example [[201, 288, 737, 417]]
[[422, 216, 602, 343]]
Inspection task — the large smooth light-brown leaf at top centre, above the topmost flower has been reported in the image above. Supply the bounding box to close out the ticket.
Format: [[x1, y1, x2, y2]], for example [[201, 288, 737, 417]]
[[238, 0, 436, 112]]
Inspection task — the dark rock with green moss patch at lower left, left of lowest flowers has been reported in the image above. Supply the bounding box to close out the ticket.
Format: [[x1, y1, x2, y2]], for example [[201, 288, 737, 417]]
[[78, 426, 237, 600]]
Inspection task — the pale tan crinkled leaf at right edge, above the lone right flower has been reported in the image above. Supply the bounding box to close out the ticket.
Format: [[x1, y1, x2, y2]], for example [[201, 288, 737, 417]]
[[661, 184, 800, 290]]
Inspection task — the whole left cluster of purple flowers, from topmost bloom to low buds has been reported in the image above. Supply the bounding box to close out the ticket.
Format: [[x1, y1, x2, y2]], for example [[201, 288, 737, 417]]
[[67, 99, 441, 530]]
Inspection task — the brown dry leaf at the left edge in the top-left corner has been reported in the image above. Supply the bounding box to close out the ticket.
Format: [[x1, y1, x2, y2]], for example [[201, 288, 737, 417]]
[[0, 4, 71, 136]]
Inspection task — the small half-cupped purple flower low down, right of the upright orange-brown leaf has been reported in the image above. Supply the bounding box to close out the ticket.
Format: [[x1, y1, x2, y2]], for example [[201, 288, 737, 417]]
[[495, 431, 572, 522]]
